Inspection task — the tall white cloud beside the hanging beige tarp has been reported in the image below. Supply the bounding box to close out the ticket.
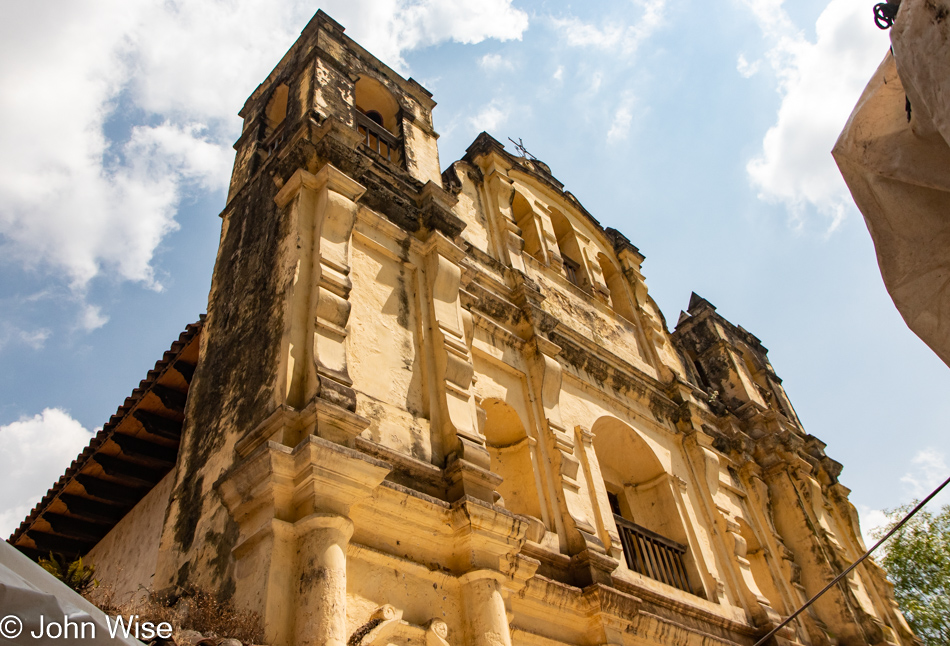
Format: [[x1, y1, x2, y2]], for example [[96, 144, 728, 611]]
[[739, 0, 889, 231]]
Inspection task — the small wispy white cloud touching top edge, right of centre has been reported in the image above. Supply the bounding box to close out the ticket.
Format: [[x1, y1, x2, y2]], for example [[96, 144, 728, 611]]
[[552, 0, 666, 56]]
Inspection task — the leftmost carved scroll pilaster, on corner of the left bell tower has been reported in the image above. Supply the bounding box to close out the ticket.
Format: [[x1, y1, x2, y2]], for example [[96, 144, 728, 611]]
[[274, 164, 365, 418]]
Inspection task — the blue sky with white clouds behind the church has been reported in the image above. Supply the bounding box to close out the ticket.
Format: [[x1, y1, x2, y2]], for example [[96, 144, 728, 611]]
[[0, 0, 950, 534]]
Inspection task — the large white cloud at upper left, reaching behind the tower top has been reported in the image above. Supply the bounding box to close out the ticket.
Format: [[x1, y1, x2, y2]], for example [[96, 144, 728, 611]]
[[0, 0, 528, 329]]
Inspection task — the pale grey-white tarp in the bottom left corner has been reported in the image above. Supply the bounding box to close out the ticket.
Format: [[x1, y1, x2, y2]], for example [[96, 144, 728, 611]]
[[0, 541, 142, 646]]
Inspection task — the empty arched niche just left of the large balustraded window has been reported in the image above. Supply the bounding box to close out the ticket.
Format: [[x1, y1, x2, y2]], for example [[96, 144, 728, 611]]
[[480, 399, 545, 521]]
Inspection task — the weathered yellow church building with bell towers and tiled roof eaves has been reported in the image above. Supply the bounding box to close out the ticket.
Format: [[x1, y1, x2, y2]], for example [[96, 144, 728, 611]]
[[11, 13, 916, 646]]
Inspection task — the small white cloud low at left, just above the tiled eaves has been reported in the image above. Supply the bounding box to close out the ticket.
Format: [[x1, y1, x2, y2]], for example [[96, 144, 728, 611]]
[[0, 408, 92, 537]]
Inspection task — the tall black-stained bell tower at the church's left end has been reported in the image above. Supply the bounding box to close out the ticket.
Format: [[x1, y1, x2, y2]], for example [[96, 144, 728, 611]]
[[154, 12, 527, 646]]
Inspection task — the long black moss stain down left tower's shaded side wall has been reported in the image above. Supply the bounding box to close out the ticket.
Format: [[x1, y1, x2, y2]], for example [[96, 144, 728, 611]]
[[174, 162, 292, 577]]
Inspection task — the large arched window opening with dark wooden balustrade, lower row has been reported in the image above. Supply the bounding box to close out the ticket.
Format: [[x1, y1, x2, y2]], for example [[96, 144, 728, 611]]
[[591, 417, 700, 592]]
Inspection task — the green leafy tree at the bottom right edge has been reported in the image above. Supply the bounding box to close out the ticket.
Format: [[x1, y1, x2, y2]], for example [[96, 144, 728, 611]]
[[874, 502, 950, 646]]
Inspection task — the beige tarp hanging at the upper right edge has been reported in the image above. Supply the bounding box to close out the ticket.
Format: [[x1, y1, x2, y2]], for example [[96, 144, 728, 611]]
[[832, 0, 950, 365]]
